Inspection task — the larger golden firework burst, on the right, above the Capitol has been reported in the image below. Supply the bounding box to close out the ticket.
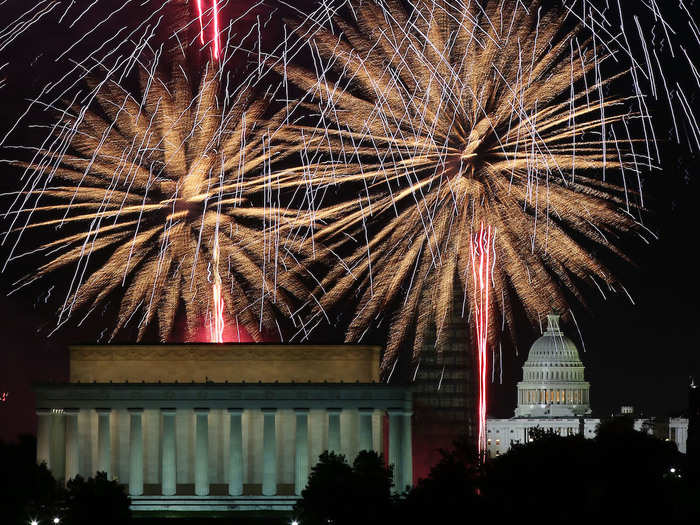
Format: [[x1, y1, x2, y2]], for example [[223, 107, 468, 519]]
[[278, 1, 654, 367]]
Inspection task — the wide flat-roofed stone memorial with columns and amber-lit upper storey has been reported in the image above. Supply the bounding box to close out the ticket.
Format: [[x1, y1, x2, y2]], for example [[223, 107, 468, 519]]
[[35, 344, 413, 511]]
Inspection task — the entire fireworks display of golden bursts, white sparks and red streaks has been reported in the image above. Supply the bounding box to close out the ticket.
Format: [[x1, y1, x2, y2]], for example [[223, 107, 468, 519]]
[[0, 0, 700, 450]]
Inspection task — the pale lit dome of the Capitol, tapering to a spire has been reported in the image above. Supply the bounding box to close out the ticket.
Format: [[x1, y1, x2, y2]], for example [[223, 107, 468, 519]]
[[515, 314, 591, 417]]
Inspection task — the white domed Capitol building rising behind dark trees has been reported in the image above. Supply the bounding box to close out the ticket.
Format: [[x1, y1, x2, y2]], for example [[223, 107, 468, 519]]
[[486, 314, 688, 457]]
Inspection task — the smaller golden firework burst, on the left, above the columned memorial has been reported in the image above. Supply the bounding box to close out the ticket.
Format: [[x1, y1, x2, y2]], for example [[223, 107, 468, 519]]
[[2, 46, 303, 341]]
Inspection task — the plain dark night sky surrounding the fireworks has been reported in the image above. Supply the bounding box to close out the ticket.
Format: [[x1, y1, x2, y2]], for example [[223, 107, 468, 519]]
[[0, 0, 700, 439]]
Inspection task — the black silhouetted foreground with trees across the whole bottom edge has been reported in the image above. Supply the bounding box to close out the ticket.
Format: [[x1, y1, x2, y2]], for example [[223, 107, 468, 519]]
[[0, 418, 700, 525]]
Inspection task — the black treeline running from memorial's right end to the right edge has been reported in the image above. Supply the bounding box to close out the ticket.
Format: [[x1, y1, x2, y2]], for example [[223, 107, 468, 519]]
[[295, 418, 700, 525]]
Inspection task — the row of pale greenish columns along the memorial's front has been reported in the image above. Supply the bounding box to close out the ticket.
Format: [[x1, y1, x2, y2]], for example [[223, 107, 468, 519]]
[[37, 398, 412, 497]]
